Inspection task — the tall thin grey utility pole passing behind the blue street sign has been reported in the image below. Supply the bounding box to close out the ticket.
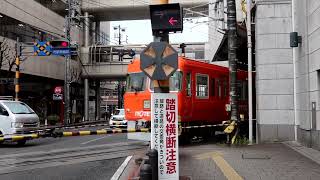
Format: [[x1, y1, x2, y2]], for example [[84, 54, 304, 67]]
[[64, 0, 73, 125]]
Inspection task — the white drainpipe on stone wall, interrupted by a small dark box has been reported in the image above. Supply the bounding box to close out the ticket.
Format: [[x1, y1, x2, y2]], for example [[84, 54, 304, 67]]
[[291, 0, 299, 141]]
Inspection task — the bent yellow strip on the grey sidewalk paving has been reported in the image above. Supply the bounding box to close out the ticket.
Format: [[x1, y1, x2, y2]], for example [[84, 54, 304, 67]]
[[195, 152, 243, 180]]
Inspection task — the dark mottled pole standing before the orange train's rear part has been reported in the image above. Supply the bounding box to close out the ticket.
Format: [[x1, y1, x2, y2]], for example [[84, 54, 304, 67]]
[[227, 0, 239, 122]]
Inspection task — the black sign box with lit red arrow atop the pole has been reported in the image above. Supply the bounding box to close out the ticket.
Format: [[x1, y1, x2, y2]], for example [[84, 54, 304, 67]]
[[149, 3, 183, 34]]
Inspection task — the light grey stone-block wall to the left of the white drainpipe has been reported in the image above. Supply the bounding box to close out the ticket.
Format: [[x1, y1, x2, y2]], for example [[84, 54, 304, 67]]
[[255, 0, 294, 142]]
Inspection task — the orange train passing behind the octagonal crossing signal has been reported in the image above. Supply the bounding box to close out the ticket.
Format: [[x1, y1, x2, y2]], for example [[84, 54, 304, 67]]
[[124, 57, 248, 136]]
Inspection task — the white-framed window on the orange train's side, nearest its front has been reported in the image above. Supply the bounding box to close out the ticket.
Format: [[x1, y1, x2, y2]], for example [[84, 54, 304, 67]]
[[196, 74, 209, 98]]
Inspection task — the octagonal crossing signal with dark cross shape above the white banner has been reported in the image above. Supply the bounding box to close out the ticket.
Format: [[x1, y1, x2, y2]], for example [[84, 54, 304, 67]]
[[140, 42, 178, 80]]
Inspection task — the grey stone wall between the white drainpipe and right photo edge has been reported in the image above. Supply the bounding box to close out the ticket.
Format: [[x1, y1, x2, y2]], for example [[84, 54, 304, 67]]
[[295, 0, 320, 150]]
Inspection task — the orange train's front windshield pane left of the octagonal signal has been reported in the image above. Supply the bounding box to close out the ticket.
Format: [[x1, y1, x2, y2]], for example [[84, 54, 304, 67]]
[[127, 72, 146, 92]]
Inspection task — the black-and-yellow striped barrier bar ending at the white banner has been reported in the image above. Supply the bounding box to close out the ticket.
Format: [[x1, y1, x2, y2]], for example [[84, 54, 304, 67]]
[[53, 128, 150, 137]]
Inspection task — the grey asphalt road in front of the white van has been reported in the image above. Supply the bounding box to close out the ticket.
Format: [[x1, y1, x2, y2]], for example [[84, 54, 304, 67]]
[[0, 125, 148, 180]]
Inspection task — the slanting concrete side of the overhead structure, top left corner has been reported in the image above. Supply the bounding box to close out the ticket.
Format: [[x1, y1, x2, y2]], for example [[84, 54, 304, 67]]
[[0, 0, 64, 35]]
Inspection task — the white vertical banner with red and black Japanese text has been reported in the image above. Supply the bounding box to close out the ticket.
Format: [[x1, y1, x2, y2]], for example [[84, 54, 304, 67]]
[[151, 93, 179, 180]]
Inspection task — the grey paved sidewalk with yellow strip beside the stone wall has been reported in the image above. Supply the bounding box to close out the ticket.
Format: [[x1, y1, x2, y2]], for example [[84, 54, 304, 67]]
[[121, 142, 320, 180]]
